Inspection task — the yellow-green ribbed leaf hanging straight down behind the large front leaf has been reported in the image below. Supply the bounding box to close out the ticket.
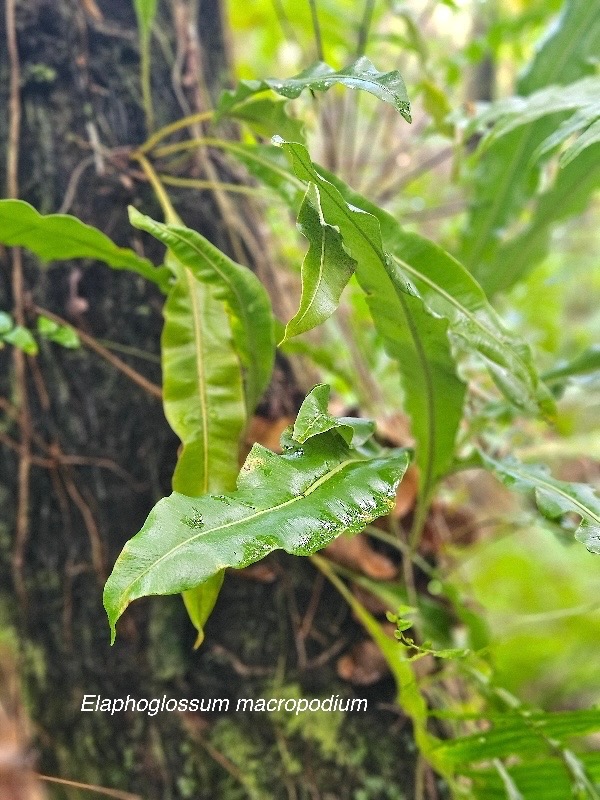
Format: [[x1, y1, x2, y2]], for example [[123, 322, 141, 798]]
[[130, 204, 252, 647]]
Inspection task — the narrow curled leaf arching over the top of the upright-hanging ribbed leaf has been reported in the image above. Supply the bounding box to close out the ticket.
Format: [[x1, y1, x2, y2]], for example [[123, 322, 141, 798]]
[[129, 208, 275, 414]]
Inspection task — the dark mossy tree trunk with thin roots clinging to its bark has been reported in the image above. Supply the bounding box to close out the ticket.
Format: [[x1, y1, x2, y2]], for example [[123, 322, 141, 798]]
[[0, 0, 414, 800]]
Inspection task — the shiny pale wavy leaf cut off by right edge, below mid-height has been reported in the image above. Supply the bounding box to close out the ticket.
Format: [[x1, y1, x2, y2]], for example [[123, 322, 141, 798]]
[[479, 453, 600, 553]]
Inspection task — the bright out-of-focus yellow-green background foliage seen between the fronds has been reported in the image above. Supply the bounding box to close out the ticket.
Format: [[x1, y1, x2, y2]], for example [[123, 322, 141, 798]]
[[228, 0, 600, 708]]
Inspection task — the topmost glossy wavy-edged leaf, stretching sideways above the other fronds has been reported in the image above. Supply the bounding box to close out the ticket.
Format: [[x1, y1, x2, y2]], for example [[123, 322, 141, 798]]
[[217, 56, 411, 122]]
